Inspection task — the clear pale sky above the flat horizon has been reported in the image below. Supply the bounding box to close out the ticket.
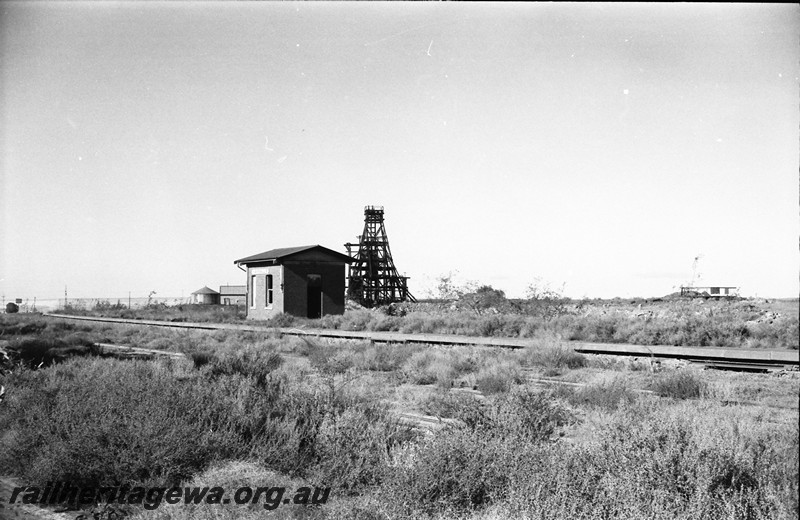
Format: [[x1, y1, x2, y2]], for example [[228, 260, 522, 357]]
[[0, 1, 800, 299]]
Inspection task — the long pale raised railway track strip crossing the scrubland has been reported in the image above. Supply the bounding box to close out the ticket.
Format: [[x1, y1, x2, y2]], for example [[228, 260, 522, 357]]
[[44, 313, 800, 371]]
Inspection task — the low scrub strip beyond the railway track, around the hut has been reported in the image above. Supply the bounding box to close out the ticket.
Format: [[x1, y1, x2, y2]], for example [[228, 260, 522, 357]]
[[50, 286, 800, 349]]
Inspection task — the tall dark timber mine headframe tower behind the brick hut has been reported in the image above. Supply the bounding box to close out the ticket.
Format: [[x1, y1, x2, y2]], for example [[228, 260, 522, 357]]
[[345, 206, 416, 307]]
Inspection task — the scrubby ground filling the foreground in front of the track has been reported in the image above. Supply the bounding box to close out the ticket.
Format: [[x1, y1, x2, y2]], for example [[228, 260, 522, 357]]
[[0, 311, 800, 520]]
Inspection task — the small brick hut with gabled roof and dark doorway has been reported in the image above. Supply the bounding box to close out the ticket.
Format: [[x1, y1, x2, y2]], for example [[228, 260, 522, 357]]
[[234, 245, 353, 320]]
